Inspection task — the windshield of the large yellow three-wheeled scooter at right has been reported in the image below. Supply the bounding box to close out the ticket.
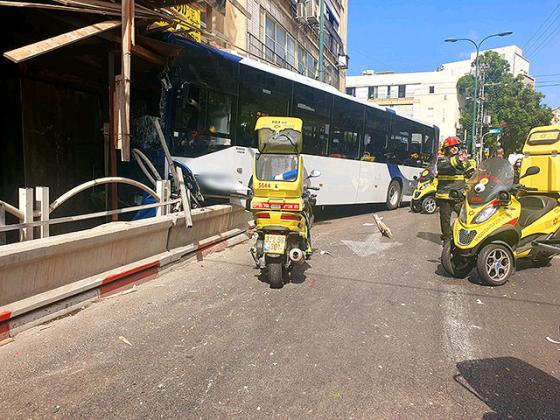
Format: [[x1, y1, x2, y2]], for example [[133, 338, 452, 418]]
[[467, 158, 514, 206]]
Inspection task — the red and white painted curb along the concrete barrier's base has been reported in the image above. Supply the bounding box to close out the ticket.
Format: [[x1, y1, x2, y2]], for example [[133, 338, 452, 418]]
[[0, 229, 250, 346]]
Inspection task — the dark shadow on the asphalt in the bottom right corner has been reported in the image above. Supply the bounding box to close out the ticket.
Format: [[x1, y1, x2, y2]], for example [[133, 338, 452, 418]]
[[453, 357, 560, 420]]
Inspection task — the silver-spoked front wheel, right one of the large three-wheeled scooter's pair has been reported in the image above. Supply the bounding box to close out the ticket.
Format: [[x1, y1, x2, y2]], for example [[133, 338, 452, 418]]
[[476, 243, 515, 286]]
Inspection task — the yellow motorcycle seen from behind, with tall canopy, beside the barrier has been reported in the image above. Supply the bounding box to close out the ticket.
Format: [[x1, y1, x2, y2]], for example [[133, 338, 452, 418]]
[[250, 117, 321, 288]]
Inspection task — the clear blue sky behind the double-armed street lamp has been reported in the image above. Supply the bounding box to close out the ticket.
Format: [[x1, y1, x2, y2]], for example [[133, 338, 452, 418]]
[[348, 0, 560, 108]]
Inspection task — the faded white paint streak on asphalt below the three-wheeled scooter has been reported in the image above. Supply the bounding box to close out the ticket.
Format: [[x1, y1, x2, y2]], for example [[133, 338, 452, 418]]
[[443, 286, 476, 362]]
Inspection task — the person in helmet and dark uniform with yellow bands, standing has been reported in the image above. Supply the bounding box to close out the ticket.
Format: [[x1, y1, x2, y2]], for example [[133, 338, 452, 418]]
[[436, 137, 471, 242]]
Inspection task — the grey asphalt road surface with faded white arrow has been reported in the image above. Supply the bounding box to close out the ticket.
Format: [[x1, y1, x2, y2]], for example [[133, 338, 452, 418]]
[[0, 208, 560, 419]]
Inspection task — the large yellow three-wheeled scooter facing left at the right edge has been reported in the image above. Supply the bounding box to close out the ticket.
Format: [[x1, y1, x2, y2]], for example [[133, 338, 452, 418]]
[[441, 127, 560, 286]]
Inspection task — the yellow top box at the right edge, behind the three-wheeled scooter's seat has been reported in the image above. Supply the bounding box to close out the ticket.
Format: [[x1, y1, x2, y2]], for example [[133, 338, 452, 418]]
[[521, 125, 560, 193]]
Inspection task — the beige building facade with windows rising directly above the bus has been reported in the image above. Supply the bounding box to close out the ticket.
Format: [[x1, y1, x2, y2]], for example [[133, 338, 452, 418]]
[[195, 0, 348, 90]]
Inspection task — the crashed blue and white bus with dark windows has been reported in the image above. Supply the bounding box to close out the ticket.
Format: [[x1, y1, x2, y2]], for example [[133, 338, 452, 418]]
[[165, 39, 439, 209]]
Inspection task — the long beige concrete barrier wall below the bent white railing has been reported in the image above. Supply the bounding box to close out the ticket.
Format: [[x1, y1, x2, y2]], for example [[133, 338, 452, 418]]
[[0, 205, 252, 314]]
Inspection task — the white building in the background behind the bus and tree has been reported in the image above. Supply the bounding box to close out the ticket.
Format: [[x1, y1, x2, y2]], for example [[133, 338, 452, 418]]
[[346, 46, 534, 140]]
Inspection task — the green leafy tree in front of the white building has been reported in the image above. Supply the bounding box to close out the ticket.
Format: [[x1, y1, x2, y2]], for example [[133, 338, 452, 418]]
[[457, 51, 553, 153]]
